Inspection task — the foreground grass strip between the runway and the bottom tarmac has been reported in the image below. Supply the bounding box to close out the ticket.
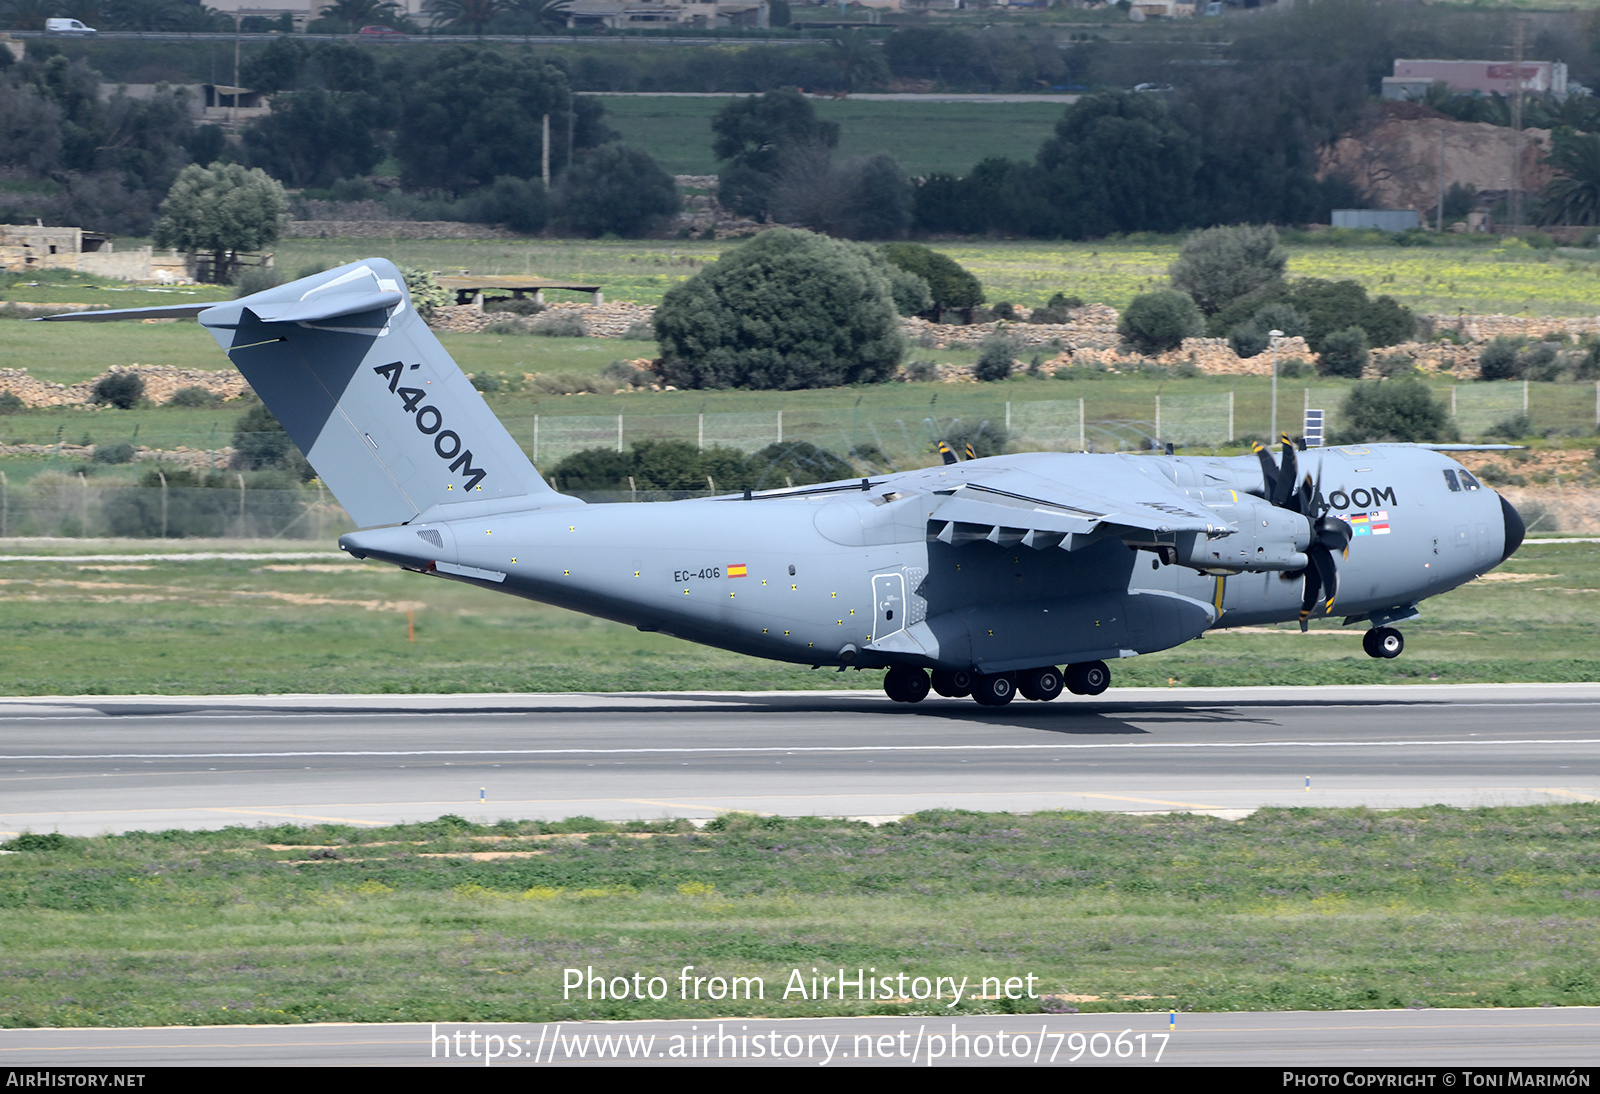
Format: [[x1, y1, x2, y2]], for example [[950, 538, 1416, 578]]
[[0, 805, 1600, 1027]]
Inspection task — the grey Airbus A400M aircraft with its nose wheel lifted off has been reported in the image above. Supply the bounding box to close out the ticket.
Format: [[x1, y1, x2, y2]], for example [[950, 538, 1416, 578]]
[[40, 259, 1523, 705]]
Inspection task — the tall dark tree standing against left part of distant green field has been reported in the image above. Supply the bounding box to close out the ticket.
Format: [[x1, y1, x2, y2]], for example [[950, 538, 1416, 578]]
[[710, 88, 838, 219]]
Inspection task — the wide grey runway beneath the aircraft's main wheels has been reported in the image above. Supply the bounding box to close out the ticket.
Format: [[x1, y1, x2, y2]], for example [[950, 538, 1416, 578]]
[[0, 685, 1600, 835]]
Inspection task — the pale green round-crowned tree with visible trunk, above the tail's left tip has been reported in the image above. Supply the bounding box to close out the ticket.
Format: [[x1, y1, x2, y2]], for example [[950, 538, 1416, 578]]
[[155, 163, 288, 283]]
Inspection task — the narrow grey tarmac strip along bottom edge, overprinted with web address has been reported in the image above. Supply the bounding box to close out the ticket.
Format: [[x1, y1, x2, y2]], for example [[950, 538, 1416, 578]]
[[0, 1006, 1600, 1068]]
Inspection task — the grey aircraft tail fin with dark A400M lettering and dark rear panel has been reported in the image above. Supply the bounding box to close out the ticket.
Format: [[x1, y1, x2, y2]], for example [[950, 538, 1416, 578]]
[[43, 259, 581, 528]]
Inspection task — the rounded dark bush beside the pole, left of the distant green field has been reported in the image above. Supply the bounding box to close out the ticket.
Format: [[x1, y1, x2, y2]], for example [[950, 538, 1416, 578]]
[[552, 144, 682, 237]]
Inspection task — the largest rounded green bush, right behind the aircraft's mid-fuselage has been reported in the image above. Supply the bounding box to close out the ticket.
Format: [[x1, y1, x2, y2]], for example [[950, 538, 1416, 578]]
[[656, 229, 906, 390]]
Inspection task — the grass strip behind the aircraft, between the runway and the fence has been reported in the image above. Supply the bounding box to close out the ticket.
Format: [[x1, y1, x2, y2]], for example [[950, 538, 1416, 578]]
[[0, 541, 1600, 696]]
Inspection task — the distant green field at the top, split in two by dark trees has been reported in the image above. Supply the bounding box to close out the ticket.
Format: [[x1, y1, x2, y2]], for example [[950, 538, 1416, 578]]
[[602, 94, 1067, 176]]
